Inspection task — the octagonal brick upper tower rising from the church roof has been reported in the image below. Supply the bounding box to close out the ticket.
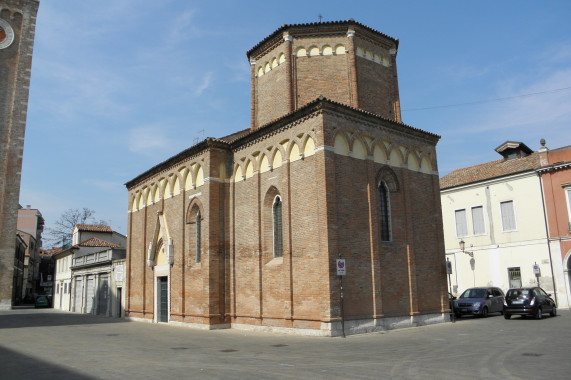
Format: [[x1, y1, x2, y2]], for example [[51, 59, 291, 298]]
[[247, 19, 401, 129]]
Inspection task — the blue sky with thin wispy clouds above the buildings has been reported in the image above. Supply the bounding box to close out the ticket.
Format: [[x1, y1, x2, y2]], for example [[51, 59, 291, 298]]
[[20, 0, 571, 242]]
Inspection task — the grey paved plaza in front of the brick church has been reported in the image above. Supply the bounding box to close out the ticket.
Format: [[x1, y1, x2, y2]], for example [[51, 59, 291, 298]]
[[0, 309, 571, 379]]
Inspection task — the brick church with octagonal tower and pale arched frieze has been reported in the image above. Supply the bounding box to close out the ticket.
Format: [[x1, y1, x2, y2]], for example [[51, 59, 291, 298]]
[[126, 19, 448, 336]]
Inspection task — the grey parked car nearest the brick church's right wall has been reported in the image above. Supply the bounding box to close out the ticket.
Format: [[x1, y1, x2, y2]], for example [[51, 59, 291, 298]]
[[454, 287, 504, 318]]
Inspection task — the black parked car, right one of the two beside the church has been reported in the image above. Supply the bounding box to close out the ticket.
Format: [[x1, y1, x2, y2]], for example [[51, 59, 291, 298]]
[[504, 287, 557, 319]]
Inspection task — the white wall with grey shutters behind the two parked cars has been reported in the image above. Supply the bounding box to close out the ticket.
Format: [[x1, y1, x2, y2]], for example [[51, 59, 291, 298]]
[[441, 172, 568, 307]]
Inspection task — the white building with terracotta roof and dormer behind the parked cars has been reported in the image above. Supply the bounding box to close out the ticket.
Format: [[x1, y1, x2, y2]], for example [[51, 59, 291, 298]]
[[440, 141, 569, 308]]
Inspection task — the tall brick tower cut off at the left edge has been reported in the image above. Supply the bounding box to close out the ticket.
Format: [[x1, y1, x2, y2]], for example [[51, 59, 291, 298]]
[[0, 0, 39, 309]]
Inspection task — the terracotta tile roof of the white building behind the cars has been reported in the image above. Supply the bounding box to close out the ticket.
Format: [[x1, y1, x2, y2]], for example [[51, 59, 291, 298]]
[[440, 152, 541, 189]]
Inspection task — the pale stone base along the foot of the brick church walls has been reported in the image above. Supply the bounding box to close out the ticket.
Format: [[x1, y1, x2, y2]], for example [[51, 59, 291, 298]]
[[125, 313, 450, 337]]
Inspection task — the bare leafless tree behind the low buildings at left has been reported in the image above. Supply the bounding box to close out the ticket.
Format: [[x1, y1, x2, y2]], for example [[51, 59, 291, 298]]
[[42, 207, 108, 247]]
